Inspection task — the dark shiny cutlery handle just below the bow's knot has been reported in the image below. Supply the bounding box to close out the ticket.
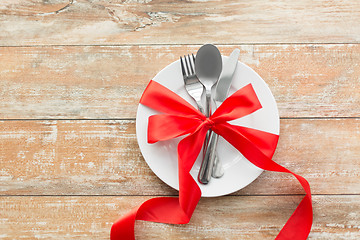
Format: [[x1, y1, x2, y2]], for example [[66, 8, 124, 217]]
[[198, 130, 219, 184]]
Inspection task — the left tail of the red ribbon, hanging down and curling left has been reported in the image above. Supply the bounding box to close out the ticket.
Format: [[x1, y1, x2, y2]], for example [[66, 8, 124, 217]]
[[110, 124, 207, 240]]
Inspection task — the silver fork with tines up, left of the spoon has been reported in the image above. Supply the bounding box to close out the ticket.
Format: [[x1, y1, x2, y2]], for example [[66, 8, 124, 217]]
[[180, 54, 223, 178]]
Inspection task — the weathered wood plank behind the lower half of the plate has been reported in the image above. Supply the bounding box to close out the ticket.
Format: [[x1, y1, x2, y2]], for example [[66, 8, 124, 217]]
[[0, 119, 360, 195]]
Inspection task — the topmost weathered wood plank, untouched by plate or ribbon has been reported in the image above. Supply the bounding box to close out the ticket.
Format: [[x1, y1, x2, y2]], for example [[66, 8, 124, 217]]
[[0, 0, 360, 46]]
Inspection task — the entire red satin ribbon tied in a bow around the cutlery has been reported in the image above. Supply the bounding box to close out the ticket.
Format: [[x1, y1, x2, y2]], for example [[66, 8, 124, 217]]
[[110, 81, 313, 240]]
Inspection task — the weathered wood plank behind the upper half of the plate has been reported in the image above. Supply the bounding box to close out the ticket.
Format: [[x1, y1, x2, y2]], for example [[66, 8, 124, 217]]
[[0, 44, 360, 119]]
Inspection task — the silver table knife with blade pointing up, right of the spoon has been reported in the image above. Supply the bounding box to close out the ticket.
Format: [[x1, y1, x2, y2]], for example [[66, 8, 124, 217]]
[[198, 48, 240, 184]]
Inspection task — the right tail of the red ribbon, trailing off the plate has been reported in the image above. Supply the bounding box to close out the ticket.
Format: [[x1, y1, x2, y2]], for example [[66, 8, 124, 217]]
[[214, 123, 313, 240]]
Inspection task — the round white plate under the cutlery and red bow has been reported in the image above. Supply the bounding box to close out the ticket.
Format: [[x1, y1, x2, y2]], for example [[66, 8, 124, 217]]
[[136, 57, 280, 197]]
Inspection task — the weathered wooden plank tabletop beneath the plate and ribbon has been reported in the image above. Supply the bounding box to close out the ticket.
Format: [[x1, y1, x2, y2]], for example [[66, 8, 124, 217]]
[[0, 0, 360, 240]]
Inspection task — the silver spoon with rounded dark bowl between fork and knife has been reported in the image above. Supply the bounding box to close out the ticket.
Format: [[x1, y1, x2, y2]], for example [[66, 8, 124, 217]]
[[195, 44, 222, 184]]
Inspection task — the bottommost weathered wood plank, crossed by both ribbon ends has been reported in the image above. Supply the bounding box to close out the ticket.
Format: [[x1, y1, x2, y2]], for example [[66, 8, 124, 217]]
[[0, 196, 360, 240]]
